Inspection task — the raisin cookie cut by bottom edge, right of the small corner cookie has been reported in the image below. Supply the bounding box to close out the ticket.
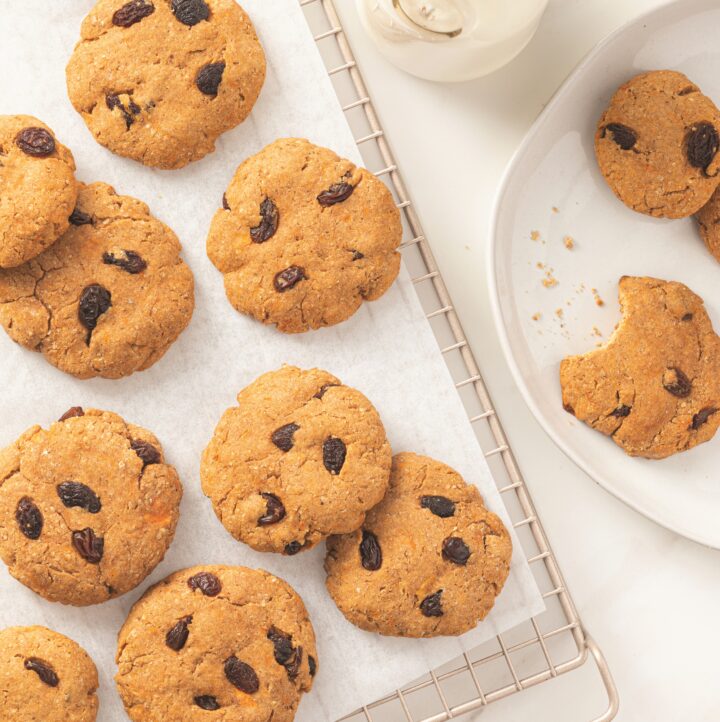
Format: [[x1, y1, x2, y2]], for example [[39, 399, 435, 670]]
[[115, 566, 318, 722]]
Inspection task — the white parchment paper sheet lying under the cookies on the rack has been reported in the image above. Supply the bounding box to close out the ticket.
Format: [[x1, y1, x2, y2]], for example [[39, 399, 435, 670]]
[[0, 0, 543, 722]]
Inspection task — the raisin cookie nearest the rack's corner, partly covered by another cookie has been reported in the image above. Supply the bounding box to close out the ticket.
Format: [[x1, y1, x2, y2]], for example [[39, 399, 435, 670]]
[[325, 453, 512, 637]]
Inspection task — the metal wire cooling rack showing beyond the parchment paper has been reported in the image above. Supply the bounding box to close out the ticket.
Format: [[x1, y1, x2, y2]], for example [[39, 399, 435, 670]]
[[298, 0, 619, 722]]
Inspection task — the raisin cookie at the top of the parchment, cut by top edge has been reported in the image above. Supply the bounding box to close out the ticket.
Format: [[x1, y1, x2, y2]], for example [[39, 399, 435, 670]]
[[66, 0, 265, 169]]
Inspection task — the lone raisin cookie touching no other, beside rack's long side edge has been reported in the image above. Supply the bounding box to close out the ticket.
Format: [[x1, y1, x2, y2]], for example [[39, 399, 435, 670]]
[[207, 138, 402, 333]]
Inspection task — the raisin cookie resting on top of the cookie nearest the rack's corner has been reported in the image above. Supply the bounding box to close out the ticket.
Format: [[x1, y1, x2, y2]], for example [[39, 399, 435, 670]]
[[200, 366, 391, 555]]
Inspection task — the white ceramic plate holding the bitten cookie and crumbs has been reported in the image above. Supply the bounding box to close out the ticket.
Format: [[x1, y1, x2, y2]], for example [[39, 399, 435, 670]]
[[488, 0, 720, 548]]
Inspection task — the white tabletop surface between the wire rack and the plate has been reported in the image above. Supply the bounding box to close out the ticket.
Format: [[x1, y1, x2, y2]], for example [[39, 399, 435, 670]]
[[337, 0, 720, 722]]
